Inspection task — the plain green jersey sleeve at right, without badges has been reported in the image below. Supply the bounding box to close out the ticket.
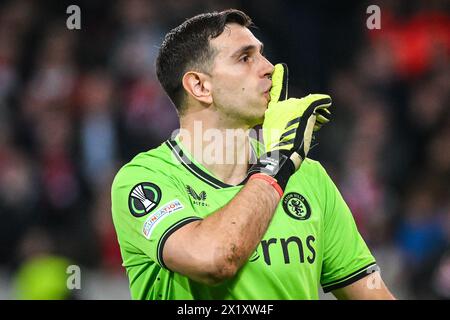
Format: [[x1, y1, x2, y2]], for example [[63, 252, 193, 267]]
[[320, 166, 378, 292]]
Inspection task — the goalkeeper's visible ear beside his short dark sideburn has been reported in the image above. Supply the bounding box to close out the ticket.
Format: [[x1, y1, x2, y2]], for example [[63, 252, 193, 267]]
[[183, 71, 213, 105]]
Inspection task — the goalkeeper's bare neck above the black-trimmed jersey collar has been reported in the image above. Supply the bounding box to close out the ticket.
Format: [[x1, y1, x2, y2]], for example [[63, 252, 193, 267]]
[[179, 110, 251, 185]]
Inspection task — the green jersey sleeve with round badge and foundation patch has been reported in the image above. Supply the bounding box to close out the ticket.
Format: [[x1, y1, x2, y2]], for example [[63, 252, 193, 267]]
[[111, 162, 201, 268]]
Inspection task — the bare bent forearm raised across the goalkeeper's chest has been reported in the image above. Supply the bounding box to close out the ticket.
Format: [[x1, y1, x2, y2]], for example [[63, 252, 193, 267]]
[[163, 179, 280, 284]]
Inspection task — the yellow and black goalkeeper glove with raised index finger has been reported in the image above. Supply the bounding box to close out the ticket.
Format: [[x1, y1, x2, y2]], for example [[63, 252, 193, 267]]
[[247, 64, 331, 191]]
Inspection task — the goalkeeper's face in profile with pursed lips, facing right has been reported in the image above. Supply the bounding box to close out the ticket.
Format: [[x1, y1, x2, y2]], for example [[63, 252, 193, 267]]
[[210, 23, 274, 127]]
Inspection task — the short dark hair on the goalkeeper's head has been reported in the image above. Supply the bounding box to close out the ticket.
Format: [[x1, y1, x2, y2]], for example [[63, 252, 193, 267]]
[[156, 9, 252, 114]]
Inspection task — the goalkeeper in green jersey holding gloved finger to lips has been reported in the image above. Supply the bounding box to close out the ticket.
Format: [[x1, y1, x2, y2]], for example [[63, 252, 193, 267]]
[[112, 10, 393, 299]]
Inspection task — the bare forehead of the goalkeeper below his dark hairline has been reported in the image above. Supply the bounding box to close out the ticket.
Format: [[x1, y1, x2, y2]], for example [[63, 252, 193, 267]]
[[211, 23, 261, 56]]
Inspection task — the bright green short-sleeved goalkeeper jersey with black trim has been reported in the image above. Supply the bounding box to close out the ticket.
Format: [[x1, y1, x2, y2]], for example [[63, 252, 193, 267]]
[[112, 138, 376, 300]]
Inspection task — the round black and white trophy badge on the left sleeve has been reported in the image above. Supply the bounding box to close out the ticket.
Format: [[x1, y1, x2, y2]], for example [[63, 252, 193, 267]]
[[128, 182, 161, 218]]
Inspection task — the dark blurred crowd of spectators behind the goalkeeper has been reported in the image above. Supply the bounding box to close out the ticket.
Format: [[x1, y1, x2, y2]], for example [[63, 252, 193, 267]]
[[0, 0, 450, 299]]
